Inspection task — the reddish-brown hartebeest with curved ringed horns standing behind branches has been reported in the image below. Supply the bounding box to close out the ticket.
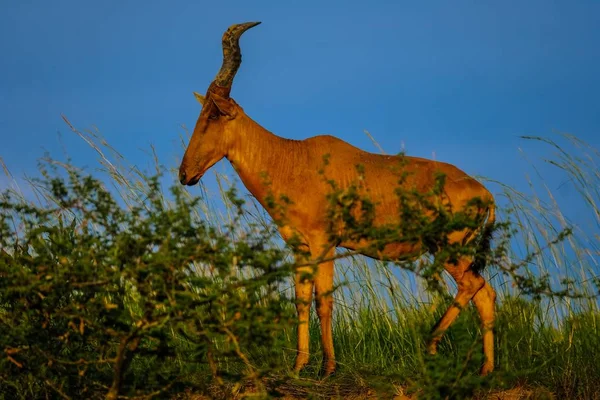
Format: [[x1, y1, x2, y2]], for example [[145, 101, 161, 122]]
[[179, 22, 496, 375]]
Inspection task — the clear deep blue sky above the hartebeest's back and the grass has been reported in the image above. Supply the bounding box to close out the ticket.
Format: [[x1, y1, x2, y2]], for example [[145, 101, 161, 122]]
[[0, 0, 600, 219]]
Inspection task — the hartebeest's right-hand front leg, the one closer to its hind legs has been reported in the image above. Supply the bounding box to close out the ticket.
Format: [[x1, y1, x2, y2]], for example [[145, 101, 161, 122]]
[[315, 250, 335, 377]]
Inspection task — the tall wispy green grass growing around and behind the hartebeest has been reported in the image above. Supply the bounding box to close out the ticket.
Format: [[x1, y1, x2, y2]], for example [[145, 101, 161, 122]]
[[0, 123, 600, 399]]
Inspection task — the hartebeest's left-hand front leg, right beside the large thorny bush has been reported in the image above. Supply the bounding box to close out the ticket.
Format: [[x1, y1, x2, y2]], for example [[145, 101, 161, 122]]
[[294, 260, 313, 372]]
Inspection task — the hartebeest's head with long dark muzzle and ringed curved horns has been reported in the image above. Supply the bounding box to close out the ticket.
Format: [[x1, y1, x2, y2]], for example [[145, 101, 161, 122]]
[[179, 22, 260, 186]]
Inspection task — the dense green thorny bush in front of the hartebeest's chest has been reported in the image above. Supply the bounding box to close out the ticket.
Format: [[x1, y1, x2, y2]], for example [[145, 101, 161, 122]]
[[0, 164, 293, 399]]
